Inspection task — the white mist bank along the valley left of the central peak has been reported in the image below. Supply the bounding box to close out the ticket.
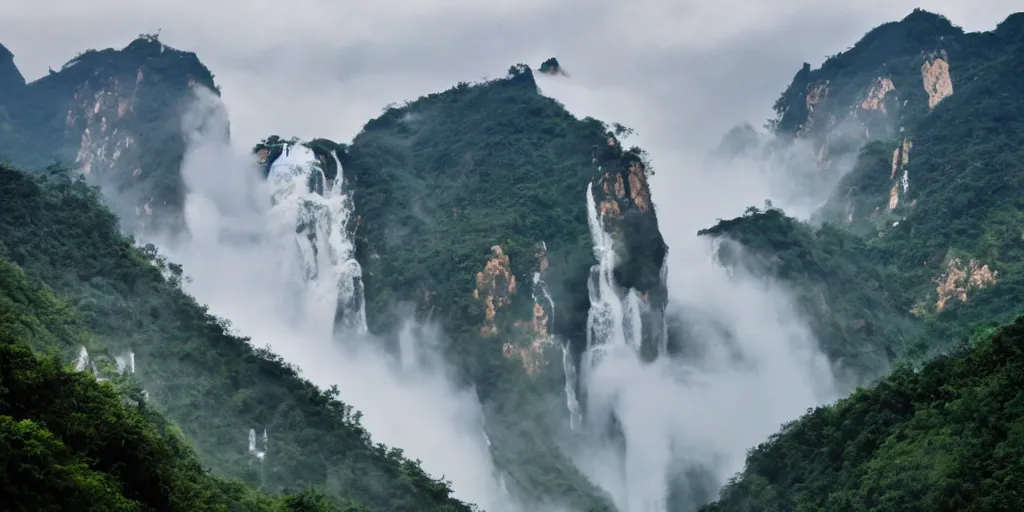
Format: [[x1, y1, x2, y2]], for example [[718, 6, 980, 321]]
[[144, 89, 520, 511]]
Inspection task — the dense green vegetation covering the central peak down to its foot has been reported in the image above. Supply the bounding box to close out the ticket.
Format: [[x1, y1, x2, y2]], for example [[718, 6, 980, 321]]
[[303, 65, 665, 510]]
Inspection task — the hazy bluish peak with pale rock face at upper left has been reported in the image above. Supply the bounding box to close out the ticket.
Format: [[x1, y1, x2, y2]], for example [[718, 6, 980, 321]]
[[0, 36, 216, 228]]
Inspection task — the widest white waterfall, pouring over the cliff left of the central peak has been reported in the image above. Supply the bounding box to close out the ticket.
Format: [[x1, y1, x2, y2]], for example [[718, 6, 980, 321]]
[[267, 145, 367, 334]]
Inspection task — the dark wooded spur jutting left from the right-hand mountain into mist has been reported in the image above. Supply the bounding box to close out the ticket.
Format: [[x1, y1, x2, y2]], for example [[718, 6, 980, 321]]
[[698, 207, 919, 381]]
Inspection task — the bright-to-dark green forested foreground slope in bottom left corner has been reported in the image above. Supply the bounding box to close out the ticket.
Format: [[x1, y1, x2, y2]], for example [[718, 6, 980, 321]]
[[0, 256, 352, 512]]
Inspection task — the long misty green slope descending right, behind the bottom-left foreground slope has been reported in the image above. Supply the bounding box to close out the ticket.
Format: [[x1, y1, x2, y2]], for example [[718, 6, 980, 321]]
[[0, 161, 469, 511]]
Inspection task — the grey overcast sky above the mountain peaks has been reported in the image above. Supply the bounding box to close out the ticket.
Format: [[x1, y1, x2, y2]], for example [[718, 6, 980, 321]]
[[0, 0, 1021, 157]]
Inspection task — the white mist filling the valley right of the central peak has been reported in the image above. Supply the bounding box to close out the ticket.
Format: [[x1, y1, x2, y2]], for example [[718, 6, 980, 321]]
[[541, 74, 853, 512]]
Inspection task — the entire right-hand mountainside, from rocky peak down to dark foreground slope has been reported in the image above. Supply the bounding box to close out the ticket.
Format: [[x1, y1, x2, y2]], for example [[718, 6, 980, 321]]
[[701, 9, 1024, 510]]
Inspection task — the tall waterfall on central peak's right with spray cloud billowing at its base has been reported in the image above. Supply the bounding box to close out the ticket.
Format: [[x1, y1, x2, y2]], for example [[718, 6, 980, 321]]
[[566, 180, 834, 512]]
